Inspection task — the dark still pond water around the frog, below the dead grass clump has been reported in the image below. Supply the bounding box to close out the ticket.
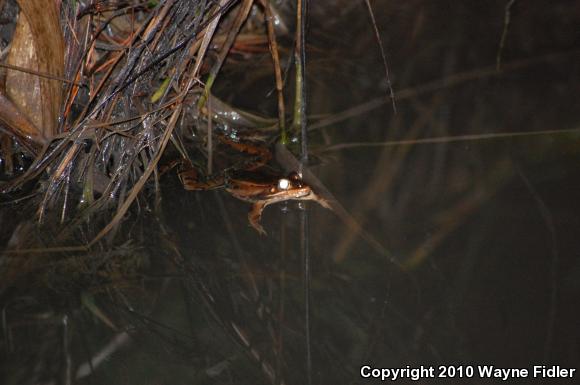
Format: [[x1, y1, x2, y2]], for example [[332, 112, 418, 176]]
[[0, 1, 580, 384]]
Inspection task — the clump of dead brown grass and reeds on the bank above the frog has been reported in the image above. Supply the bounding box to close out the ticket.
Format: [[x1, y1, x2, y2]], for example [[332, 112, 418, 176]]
[[0, 1, 294, 245]]
